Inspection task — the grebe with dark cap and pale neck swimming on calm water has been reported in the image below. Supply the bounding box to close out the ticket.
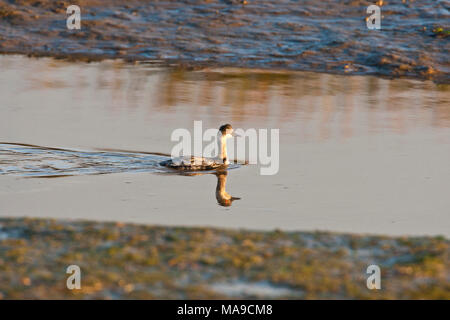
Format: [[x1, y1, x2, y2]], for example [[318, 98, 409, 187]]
[[159, 124, 235, 171]]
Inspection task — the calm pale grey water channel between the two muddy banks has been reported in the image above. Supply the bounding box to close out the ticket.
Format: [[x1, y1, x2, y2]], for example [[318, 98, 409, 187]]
[[0, 56, 450, 236]]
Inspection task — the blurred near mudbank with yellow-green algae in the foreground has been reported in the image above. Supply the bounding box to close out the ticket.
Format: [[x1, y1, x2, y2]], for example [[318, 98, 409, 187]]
[[0, 218, 450, 299]]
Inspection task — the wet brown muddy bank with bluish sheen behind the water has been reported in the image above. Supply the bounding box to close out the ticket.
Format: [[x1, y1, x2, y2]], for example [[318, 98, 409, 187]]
[[0, 0, 450, 83]]
